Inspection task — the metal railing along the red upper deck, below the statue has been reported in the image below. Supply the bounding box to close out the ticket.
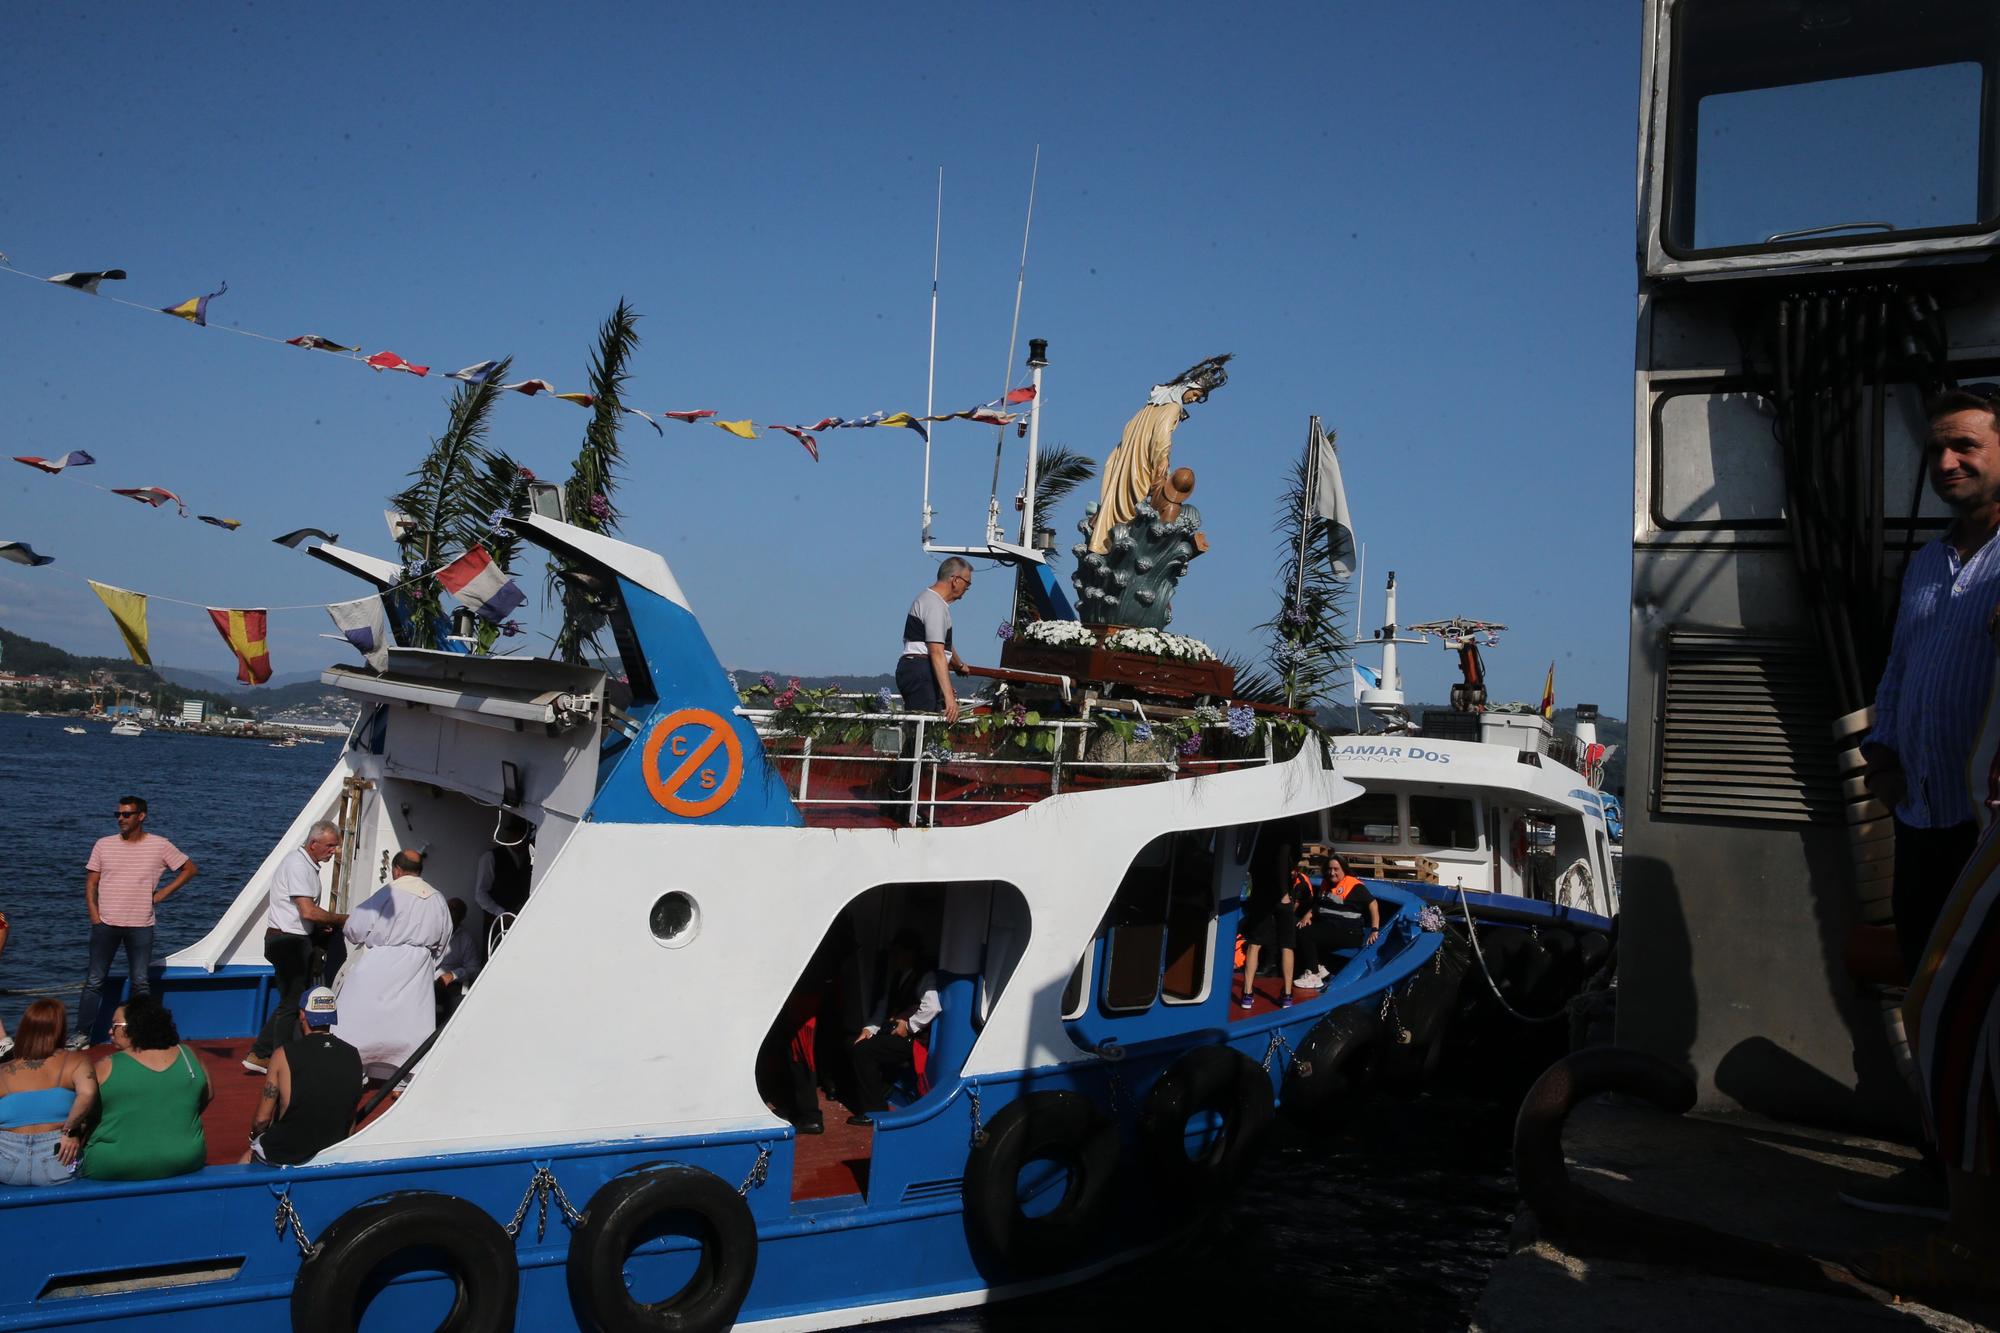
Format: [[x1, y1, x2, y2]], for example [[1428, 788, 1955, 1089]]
[[736, 695, 1280, 827]]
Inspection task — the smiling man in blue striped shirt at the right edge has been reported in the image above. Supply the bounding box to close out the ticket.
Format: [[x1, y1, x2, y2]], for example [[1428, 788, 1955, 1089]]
[[1862, 384, 2000, 975]]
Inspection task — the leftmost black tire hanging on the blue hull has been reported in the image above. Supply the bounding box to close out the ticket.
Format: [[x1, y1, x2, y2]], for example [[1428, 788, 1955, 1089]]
[[292, 1189, 520, 1333]]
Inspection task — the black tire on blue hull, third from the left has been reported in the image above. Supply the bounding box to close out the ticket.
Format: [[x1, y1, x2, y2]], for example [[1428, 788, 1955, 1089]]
[[964, 1091, 1118, 1271]]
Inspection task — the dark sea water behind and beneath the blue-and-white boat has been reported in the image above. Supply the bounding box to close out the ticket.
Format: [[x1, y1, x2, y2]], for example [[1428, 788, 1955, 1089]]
[[0, 715, 1514, 1333]]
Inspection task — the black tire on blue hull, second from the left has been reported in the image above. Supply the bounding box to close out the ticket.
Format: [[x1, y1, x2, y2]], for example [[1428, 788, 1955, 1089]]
[[566, 1163, 756, 1333]]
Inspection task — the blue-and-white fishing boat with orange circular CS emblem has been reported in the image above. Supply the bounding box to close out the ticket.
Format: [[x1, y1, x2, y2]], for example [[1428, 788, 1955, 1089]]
[[0, 360, 1444, 1331]]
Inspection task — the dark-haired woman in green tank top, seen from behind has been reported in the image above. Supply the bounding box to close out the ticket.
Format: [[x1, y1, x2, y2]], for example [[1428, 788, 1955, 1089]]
[[84, 995, 208, 1181]]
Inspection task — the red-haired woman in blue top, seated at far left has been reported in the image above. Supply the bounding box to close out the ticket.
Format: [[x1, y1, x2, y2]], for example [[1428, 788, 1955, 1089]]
[[0, 999, 98, 1185]]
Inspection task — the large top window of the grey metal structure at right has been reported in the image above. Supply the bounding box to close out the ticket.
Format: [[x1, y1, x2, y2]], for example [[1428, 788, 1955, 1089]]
[[1666, 0, 2000, 254]]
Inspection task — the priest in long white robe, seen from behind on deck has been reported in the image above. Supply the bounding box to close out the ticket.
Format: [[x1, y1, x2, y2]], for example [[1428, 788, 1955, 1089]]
[[334, 849, 452, 1079]]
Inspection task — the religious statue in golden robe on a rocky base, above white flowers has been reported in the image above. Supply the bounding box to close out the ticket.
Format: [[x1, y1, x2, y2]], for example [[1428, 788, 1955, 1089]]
[[1070, 354, 1230, 628]]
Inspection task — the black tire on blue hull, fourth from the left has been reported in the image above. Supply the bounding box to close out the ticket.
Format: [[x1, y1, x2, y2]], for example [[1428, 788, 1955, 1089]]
[[1138, 1045, 1272, 1203]]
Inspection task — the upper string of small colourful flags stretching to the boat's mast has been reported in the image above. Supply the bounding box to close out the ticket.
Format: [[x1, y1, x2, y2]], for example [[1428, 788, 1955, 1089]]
[[0, 254, 1036, 456]]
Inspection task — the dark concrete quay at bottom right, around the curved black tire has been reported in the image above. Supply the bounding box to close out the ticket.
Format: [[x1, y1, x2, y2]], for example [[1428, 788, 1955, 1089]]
[[1470, 1099, 2000, 1333]]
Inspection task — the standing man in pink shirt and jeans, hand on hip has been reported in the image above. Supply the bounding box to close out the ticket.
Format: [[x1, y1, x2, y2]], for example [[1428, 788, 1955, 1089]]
[[70, 797, 196, 1049]]
